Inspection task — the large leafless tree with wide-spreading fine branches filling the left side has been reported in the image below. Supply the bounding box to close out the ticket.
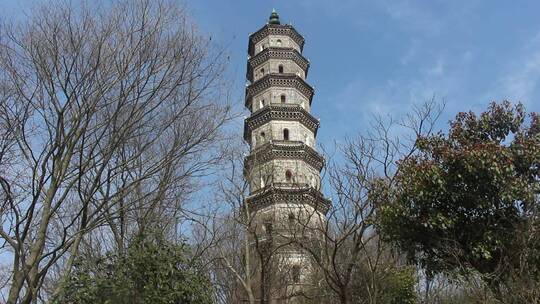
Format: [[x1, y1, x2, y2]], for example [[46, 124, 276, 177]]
[[0, 0, 230, 303]]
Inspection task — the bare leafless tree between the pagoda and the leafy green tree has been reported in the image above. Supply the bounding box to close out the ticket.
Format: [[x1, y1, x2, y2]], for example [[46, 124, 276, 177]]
[[288, 100, 442, 304]]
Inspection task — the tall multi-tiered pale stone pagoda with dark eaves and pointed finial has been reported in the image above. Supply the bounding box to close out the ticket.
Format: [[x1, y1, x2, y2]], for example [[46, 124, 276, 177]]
[[244, 10, 329, 303]]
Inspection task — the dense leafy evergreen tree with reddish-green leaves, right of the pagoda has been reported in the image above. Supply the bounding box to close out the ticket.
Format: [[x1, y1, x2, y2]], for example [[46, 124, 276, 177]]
[[378, 102, 540, 278]]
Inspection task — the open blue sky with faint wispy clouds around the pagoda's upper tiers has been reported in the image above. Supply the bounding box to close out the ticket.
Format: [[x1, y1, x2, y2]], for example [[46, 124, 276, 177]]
[[0, 0, 540, 145]]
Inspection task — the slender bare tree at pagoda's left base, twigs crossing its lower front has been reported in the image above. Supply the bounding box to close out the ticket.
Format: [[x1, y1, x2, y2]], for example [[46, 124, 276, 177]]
[[196, 144, 306, 304]]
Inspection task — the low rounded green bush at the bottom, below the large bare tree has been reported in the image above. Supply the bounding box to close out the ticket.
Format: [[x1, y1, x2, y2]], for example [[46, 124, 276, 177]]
[[53, 237, 212, 304]]
